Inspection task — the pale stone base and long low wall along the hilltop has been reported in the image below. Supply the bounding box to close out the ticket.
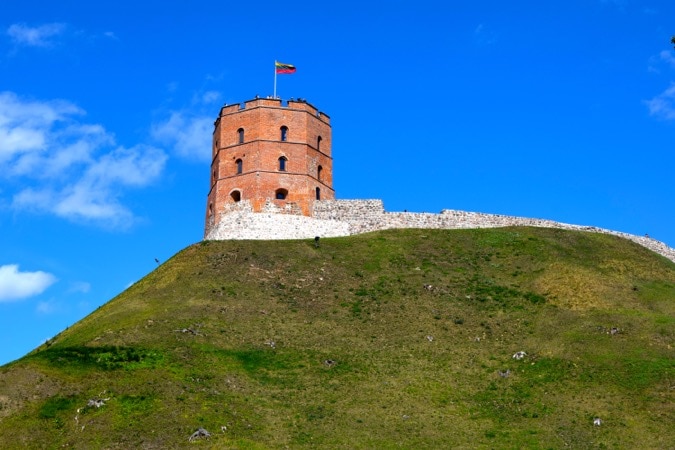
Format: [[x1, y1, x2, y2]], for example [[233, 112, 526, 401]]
[[205, 200, 675, 262]]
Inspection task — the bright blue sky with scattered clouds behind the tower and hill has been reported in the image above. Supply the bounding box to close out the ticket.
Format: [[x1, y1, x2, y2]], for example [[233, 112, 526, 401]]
[[0, 0, 675, 364]]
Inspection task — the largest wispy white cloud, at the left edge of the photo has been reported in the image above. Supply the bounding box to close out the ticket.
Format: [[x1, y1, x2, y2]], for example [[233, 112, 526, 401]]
[[0, 92, 167, 228]]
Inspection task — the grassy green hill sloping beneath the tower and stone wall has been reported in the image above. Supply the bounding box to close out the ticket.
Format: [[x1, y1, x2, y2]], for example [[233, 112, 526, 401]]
[[0, 228, 675, 449]]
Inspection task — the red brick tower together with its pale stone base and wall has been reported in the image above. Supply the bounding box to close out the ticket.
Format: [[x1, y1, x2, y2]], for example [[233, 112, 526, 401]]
[[204, 98, 675, 261]]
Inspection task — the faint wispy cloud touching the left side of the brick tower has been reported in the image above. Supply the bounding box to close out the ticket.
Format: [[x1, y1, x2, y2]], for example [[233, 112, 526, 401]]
[[152, 91, 221, 162]]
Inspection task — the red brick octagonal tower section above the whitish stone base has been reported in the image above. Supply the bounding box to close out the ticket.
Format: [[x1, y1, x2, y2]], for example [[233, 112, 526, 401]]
[[205, 98, 335, 235]]
